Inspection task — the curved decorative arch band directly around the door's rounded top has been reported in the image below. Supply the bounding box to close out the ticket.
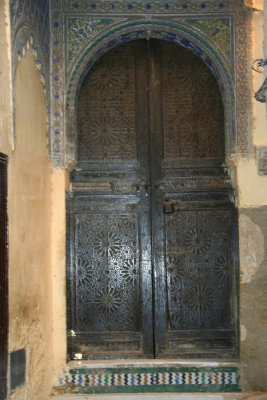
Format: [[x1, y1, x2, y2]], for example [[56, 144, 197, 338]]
[[65, 20, 237, 164]]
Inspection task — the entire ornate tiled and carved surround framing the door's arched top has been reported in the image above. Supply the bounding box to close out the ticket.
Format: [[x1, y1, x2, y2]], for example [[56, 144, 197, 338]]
[[50, 0, 249, 167]]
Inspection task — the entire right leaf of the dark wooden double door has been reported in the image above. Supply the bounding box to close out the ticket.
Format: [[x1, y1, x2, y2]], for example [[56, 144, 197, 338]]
[[150, 41, 240, 358]]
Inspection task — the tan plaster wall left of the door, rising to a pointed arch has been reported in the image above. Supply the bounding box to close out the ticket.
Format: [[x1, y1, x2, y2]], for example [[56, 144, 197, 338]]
[[8, 48, 52, 400]]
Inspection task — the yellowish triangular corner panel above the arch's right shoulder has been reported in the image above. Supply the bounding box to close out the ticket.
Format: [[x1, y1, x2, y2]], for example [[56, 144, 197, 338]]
[[186, 18, 231, 59]]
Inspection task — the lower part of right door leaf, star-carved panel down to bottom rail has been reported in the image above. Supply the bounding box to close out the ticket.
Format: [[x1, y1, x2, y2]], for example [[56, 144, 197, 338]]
[[165, 203, 239, 357]]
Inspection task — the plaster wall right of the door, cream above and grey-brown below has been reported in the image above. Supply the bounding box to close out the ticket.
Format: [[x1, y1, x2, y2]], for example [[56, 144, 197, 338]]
[[237, 1, 267, 391]]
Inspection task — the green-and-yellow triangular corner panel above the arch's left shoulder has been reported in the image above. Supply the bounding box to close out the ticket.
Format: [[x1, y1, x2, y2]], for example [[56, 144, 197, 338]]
[[66, 17, 125, 61]]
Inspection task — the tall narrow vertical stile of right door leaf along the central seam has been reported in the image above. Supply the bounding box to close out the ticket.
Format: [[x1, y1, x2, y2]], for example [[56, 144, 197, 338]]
[[149, 40, 167, 355]]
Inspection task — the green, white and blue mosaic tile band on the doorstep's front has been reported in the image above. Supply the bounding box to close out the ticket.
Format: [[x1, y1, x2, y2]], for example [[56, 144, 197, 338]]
[[56, 367, 240, 393]]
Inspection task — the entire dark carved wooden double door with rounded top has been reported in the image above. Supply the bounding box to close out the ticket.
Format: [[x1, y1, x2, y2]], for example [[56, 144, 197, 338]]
[[68, 40, 238, 359]]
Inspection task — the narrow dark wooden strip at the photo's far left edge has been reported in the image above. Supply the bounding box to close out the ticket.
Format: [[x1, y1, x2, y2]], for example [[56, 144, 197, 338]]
[[0, 153, 8, 400]]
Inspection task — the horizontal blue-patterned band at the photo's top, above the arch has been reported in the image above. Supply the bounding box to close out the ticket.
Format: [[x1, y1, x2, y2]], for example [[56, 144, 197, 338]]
[[63, 0, 240, 14]]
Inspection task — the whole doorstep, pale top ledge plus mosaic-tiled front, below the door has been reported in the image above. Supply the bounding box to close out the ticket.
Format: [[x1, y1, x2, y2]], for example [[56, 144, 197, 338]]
[[54, 359, 240, 395]]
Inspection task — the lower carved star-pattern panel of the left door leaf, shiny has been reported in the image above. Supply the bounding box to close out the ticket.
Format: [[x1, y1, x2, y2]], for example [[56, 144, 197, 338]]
[[74, 212, 140, 331]]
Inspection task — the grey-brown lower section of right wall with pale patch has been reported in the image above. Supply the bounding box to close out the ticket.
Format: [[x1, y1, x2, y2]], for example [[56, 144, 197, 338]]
[[239, 206, 267, 391]]
